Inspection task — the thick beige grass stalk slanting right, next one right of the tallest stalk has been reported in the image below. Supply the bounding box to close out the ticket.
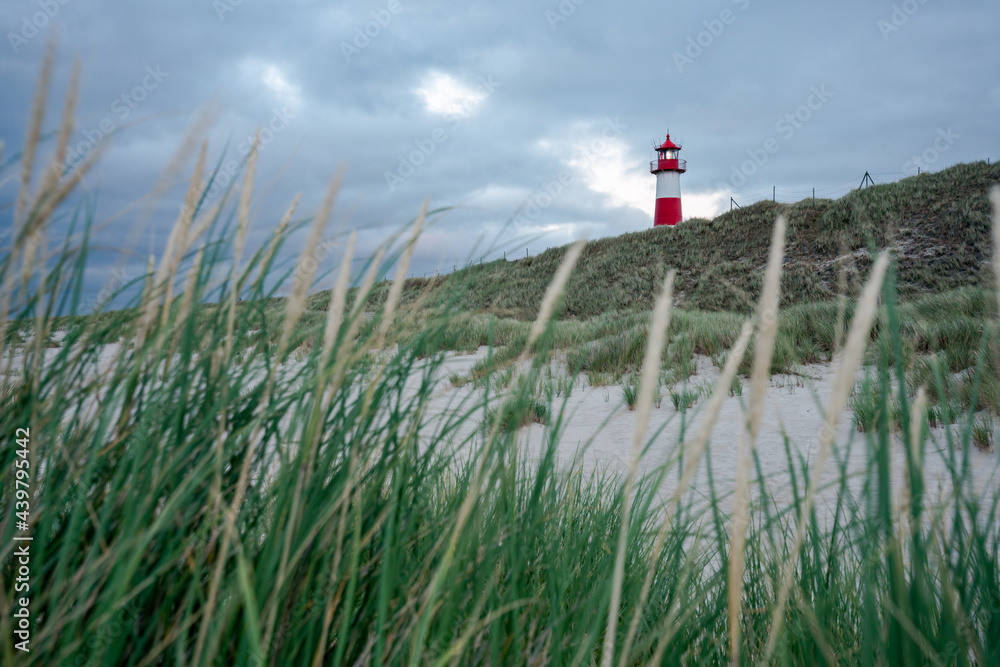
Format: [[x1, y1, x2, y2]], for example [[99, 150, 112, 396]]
[[762, 253, 889, 663]]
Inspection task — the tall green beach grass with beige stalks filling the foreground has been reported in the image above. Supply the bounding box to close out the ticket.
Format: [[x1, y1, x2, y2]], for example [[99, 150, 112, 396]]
[[0, 53, 1000, 666]]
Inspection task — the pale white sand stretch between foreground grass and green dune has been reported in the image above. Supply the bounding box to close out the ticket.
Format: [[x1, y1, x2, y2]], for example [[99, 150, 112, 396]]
[[0, 344, 1000, 528]]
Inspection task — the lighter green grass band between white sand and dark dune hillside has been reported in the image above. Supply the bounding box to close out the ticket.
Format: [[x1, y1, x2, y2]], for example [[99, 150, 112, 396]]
[[362, 287, 1000, 425]]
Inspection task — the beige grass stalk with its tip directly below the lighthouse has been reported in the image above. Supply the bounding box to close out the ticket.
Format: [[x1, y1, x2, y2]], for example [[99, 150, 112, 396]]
[[601, 269, 676, 667]]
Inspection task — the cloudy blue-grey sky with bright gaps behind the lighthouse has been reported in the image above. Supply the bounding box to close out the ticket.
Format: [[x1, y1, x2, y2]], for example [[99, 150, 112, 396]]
[[0, 0, 1000, 302]]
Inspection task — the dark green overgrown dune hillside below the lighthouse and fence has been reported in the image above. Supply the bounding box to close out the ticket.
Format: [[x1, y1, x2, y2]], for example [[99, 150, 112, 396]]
[[296, 162, 1000, 319]]
